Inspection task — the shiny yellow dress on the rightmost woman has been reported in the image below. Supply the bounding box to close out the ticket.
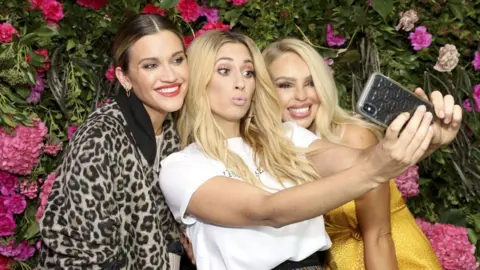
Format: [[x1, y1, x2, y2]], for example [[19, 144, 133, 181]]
[[324, 180, 442, 270]]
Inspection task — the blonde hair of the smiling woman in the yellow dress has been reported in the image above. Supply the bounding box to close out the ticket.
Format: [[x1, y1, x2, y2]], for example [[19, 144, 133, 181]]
[[263, 38, 382, 143]]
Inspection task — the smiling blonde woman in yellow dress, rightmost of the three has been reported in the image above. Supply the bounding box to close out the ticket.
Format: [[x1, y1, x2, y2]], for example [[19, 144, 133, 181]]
[[263, 38, 442, 270]]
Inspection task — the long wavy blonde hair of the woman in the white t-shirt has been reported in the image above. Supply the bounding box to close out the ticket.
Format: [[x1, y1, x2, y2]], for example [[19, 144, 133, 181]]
[[178, 30, 319, 186]]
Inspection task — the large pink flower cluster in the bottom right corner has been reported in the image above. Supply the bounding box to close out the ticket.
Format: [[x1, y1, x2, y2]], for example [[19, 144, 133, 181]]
[[415, 218, 479, 270]]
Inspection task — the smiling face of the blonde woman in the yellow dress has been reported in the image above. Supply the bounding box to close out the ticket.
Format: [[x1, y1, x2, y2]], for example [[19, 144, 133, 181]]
[[268, 52, 320, 128]]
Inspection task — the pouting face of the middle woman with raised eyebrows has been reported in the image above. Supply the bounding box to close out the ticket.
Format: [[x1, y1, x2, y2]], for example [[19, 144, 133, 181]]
[[207, 43, 255, 131]]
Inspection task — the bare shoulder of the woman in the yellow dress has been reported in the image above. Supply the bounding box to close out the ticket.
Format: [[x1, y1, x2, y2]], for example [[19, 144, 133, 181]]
[[342, 124, 378, 149]]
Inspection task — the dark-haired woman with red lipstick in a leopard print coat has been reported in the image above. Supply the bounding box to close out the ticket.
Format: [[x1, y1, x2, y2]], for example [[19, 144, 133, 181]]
[[39, 14, 188, 270]]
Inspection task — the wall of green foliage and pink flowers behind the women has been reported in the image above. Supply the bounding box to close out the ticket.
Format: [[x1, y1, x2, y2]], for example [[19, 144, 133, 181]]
[[0, 0, 480, 270]]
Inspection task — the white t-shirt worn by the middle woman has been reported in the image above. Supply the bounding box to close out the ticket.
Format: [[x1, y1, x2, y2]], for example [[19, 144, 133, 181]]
[[160, 122, 331, 270]]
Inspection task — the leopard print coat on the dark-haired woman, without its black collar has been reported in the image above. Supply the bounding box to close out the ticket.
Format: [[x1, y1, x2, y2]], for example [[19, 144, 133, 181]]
[[38, 102, 179, 270]]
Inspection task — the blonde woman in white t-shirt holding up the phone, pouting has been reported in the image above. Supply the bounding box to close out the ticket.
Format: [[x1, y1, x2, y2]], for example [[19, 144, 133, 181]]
[[160, 31, 460, 270]]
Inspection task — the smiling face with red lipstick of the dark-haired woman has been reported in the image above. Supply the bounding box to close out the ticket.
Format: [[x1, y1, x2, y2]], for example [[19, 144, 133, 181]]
[[116, 30, 188, 118]]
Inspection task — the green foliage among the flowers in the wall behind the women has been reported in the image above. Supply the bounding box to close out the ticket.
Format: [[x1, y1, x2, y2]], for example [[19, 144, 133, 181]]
[[0, 0, 480, 266]]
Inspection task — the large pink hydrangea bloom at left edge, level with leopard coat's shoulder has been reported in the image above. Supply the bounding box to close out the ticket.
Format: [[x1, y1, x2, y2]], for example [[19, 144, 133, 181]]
[[0, 120, 48, 175]]
